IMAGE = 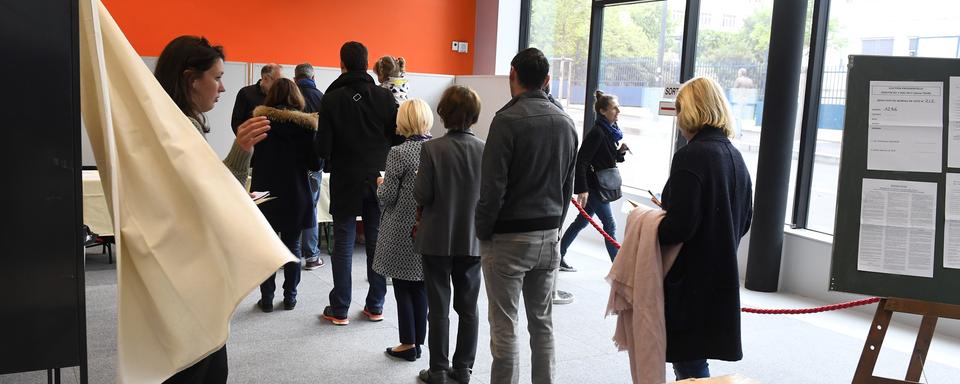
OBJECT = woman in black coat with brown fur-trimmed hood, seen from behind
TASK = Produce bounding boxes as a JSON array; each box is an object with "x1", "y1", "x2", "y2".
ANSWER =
[{"x1": 250, "y1": 79, "x2": 320, "y2": 312}]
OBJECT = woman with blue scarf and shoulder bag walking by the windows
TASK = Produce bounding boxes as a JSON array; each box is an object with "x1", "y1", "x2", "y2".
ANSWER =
[{"x1": 560, "y1": 91, "x2": 627, "y2": 272}]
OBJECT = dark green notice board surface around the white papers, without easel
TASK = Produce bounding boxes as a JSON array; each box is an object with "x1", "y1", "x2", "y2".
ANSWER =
[{"x1": 830, "y1": 56, "x2": 960, "y2": 304}]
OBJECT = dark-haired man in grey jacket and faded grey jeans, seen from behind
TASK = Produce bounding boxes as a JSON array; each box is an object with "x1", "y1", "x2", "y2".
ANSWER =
[{"x1": 476, "y1": 48, "x2": 577, "y2": 384}]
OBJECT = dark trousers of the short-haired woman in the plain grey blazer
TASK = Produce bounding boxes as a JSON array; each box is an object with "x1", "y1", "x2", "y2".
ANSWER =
[{"x1": 423, "y1": 255, "x2": 480, "y2": 371}]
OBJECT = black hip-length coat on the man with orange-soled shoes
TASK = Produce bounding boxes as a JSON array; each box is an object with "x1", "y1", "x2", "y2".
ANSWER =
[{"x1": 316, "y1": 71, "x2": 403, "y2": 216}]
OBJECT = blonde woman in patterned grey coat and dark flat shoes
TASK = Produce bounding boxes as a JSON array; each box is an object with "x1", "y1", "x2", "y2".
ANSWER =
[{"x1": 373, "y1": 99, "x2": 433, "y2": 361}]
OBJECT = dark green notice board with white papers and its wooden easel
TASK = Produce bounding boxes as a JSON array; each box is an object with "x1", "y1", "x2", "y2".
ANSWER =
[{"x1": 830, "y1": 56, "x2": 960, "y2": 383}]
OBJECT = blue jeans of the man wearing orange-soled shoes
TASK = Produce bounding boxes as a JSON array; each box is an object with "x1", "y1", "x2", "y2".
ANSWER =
[{"x1": 330, "y1": 186, "x2": 387, "y2": 316}]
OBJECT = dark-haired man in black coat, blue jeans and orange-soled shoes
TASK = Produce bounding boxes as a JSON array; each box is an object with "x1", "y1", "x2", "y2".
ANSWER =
[{"x1": 316, "y1": 41, "x2": 399, "y2": 325}]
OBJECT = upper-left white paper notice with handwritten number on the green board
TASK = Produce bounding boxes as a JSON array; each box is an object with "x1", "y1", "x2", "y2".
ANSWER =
[{"x1": 867, "y1": 81, "x2": 943, "y2": 172}]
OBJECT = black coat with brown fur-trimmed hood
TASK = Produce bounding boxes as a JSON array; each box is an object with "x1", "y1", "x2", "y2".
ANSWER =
[{"x1": 250, "y1": 106, "x2": 320, "y2": 232}]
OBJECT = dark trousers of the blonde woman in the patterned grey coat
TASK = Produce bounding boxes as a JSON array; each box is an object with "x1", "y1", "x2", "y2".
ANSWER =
[{"x1": 393, "y1": 278, "x2": 427, "y2": 345}]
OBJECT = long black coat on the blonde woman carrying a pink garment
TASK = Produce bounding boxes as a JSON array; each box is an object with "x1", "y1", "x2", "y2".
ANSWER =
[{"x1": 659, "y1": 126, "x2": 753, "y2": 362}]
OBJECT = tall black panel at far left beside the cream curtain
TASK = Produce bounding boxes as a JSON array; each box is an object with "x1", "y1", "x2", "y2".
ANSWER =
[{"x1": 0, "y1": 0, "x2": 89, "y2": 376}]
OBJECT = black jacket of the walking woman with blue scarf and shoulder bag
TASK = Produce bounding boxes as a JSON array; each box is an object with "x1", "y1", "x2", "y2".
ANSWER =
[{"x1": 573, "y1": 122, "x2": 623, "y2": 193}]
